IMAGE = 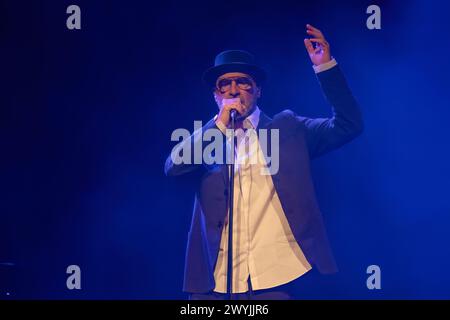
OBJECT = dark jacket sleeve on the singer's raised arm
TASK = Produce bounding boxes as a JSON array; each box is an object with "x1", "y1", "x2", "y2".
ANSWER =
[{"x1": 297, "y1": 65, "x2": 364, "y2": 158}]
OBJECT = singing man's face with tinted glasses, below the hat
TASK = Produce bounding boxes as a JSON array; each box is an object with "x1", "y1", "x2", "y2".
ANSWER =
[{"x1": 214, "y1": 72, "x2": 261, "y2": 118}]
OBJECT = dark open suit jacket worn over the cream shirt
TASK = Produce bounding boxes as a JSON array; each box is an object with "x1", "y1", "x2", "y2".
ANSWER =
[{"x1": 165, "y1": 66, "x2": 363, "y2": 293}]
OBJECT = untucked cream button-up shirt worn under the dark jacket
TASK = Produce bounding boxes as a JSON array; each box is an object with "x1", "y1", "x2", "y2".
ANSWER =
[{"x1": 214, "y1": 59, "x2": 337, "y2": 293}]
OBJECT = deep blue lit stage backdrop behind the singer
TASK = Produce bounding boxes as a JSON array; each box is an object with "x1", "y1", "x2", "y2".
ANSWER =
[{"x1": 0, "y1": 0, "x2": 450, "y2": 299}]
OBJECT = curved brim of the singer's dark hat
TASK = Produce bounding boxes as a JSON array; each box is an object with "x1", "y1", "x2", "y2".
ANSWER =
[{"x1": 202, "y1": 62, "x2": 266, "y2": 87}]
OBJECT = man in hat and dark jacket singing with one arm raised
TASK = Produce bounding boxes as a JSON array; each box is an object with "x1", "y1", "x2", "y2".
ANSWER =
[{"x1": 165, "y1": 25, "x2": 363, "y2": 299}]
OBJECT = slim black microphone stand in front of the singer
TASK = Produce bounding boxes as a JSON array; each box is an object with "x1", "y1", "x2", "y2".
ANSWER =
[{"x1": 227, "y1": 110, "x2": 236, "y2": 300}]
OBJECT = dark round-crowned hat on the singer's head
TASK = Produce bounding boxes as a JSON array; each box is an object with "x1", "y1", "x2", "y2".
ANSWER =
[{"x1": 203, "y1": 50, "x2": 266, "y2": 87}]
